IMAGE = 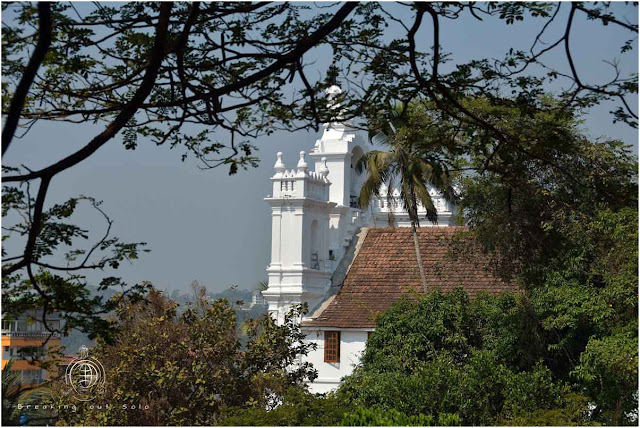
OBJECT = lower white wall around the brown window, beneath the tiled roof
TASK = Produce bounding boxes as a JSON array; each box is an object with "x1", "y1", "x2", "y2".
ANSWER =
[{"x1": 302, "y1": 327, "x2": 373, "y2": 393}]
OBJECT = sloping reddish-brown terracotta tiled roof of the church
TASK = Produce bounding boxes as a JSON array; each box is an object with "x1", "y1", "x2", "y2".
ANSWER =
[{"x1": 302, "y1": 227, "x2": 515, "y2": 328}]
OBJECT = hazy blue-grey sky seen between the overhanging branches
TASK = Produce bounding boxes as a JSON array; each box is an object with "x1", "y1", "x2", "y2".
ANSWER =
[{"x1": 3, "y1": 4, "x2": 638, "y2": 290}]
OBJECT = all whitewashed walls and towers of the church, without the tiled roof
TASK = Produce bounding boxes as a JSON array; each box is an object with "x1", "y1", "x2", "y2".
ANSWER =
[{"x1": 262, "y1": 86, "x2": 453, "y2": 393}]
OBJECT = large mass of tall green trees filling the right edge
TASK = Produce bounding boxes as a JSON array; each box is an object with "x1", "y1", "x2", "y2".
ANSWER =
[{"x1": 452, "y1": 111, "x2": 638, "y2": 425}]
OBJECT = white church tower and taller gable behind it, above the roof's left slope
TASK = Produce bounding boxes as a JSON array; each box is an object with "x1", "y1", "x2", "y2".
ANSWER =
[{"x1": 262, "y1": 86, "x2": 370, "y2": 322}]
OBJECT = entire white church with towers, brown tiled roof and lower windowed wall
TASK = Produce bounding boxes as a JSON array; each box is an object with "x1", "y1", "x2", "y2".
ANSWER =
[{"x1": 262, "y1": 87, "x2": 508, "y2": 393}]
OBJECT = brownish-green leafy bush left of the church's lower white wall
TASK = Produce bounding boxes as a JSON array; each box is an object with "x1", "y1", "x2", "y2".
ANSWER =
[{"x1": 50, "y1": 289, "x2": 316, "y2": 425}]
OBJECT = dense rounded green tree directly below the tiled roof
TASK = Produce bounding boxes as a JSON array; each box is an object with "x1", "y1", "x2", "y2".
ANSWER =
[{"x1": 339, "y1": 290, "x2": 567, "y2": 425}]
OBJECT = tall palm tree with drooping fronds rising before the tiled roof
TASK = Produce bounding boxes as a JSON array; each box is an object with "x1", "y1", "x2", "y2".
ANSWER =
[{"x1": 356, "y1": 104, "x2": 454, "y2": 292}]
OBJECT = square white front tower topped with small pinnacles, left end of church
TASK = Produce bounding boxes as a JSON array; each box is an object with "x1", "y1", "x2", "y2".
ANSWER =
[{"x1": 262, "y1": 152, "x2": 336, "y2": 323}]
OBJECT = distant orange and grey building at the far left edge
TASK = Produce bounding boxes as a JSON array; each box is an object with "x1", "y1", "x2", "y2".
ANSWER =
[{"x1": 2, "y1": 310, "x2": 61, "y2": 385}]
